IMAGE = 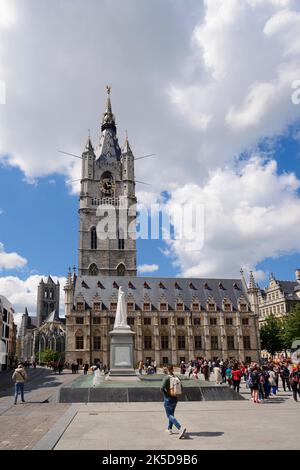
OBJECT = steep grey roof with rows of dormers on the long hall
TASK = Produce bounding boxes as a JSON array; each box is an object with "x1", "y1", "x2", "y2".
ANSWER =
[{"x1": 74, "y1": 276, "x2": 249, "y2": 309}]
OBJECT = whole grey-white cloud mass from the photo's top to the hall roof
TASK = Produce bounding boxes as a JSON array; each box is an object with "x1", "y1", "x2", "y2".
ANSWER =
[{"x1": 0, "y1": 0, "x2": 300, "y2": 275}]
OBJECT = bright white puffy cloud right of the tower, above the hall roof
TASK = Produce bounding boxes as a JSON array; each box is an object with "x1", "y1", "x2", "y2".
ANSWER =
[{"x1": 167, "y1": 157, "x2": 300, "y2": 278}]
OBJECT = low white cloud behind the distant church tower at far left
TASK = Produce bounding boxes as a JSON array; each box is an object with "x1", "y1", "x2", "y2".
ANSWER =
[{"x1": 0, "y1": 275, "x2": 66, "y2": 315}]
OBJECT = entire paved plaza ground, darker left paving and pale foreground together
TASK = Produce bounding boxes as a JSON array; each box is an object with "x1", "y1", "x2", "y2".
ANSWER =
[{"x1": 0, "y1": 369, "x2": 300, "y2": 450}]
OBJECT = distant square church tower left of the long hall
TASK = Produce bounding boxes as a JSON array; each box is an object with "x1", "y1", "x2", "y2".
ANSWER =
[{"x1": 36, "y1": 276, "x2": 60, "y2": 327}]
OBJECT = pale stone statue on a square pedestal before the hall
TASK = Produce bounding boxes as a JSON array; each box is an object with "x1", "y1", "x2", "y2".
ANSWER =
[{"x1": 107, "y1": 286, "x2": 138, "y2": 380}]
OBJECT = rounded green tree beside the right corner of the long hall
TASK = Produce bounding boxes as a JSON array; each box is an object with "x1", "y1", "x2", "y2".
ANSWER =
[{"x1": 260, "y1": 315, "x2": 285, "y2": 356}]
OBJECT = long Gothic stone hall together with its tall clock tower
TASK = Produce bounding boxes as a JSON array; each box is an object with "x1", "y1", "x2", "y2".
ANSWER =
[{"x1": 64, "y1": 87, "x2": 259, "y2": 365}]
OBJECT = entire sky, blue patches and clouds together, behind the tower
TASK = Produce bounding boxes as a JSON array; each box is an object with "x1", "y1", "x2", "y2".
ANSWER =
[{"x1": 0, "y1": 0, "x2": 300, "y2": 312}]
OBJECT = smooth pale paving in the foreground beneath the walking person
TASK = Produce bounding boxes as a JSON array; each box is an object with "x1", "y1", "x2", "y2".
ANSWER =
[{"x1": 55, "y1": 393, "x2": 300, "y2": 450}]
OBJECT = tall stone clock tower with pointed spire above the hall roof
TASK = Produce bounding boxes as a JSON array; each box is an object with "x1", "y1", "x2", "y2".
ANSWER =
[{"x1": 78, "y1": 87, "x2": 136, "y2": 276}]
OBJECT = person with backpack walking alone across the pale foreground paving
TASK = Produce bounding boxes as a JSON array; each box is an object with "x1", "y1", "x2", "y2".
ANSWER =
[{"x1": 161, "y1": 366, "x2": 186, "y2": 439}]
